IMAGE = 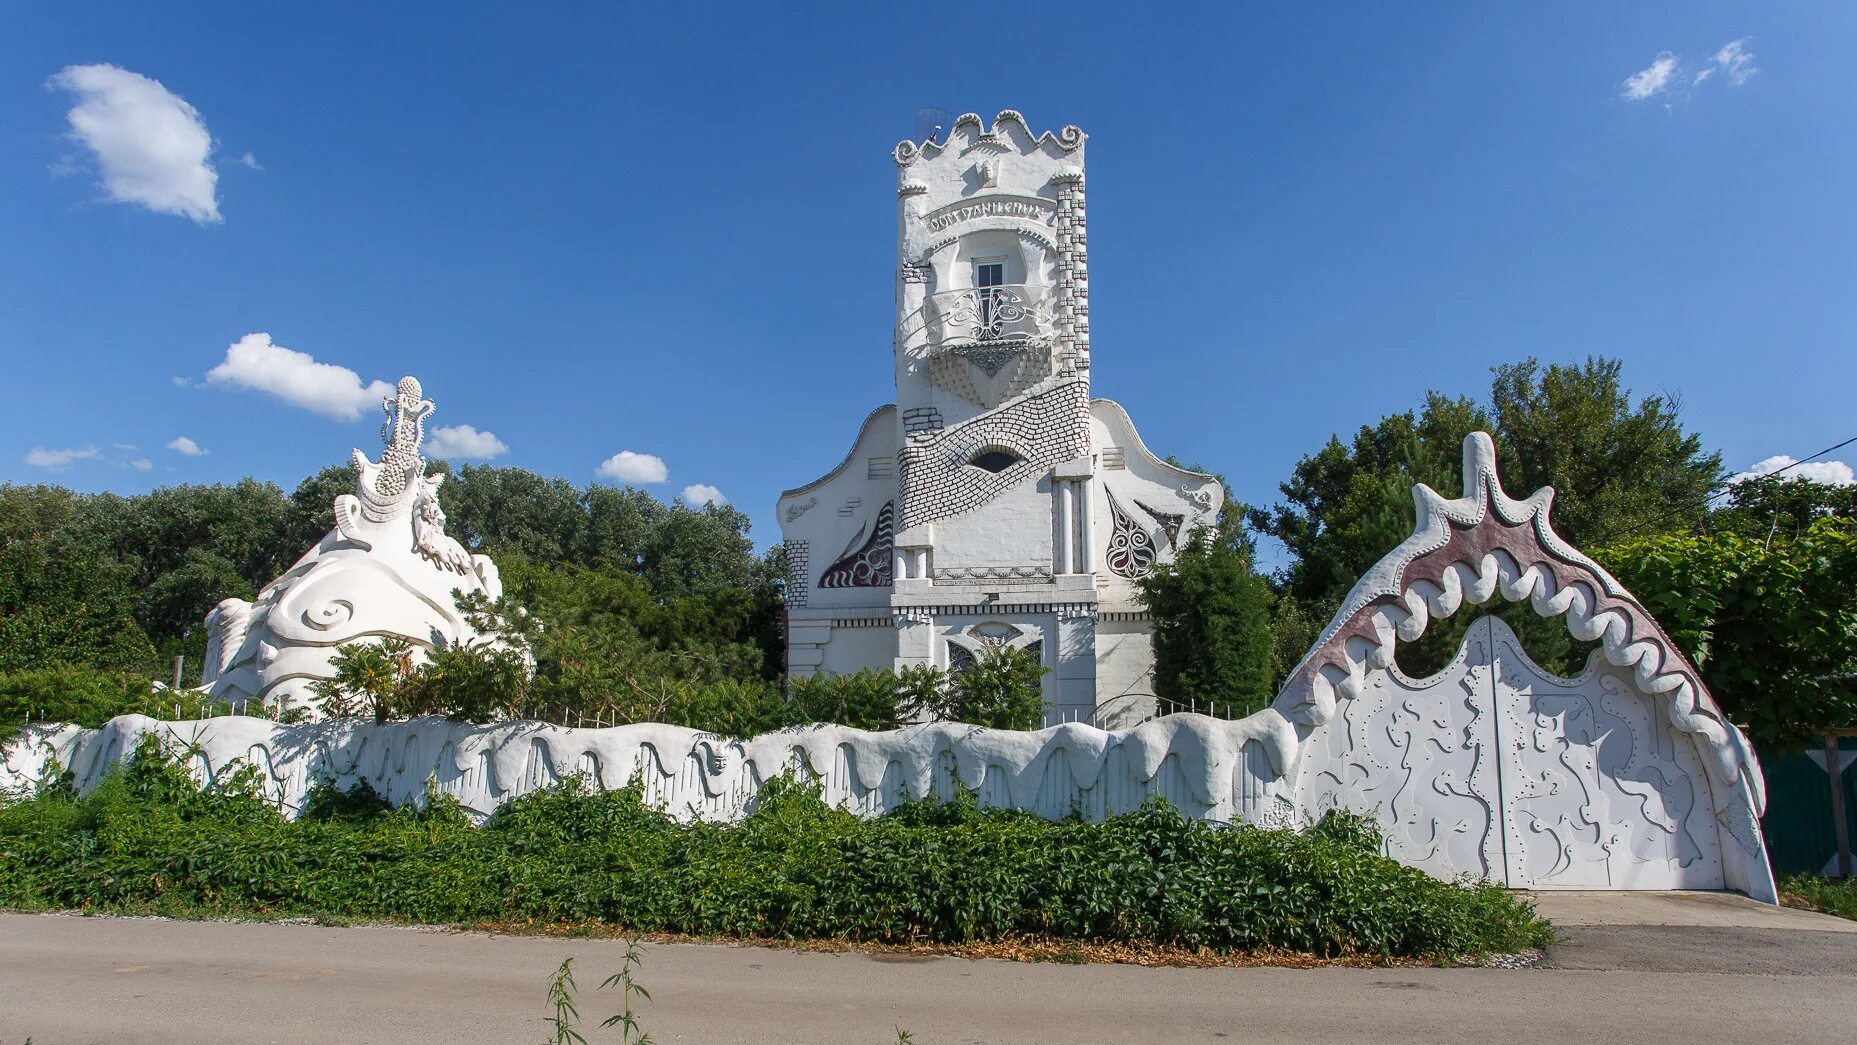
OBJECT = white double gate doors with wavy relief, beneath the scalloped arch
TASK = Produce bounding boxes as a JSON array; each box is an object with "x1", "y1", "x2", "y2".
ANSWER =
[{"x1": 1298, "y1": 616, "x2": 1723, "y2": 889}]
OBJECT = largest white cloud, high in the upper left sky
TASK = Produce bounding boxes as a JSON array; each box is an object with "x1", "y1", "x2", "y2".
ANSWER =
[{"x1": 45, "y1": 65, "x2": 219, "y2": 225}]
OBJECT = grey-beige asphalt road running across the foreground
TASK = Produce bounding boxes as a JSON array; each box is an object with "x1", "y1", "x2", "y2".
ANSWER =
[{"x1": 0, "y1": 900, "x2": 1857, "y2": 1045}]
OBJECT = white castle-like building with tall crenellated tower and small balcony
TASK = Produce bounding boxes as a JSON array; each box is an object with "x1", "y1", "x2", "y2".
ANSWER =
[{"x1": 778, "y1": 110, "x2": 1220, "y2": 728}]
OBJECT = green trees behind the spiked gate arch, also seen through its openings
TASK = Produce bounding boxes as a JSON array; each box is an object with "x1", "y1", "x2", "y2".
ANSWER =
[{"x1": 1250, "y1": 358, "x2": 1721, "y2": 676}]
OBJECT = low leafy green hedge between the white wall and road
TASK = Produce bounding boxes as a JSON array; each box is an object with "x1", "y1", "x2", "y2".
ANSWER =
[{"x1": 0, "y1": 746, "x2": 1549, "y2": 956}]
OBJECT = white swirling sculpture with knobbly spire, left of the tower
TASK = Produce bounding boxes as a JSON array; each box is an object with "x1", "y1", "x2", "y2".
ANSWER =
[{"x1": 202, "y1": 377, "x2": 503, "y2": 715}]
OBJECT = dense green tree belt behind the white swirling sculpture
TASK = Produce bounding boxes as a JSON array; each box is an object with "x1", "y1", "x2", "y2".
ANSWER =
[{"x1": 0, "y1": 462, "x2": 786, "y2": 703}]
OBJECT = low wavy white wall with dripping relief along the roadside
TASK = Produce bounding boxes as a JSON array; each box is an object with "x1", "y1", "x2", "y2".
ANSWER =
[{"x1": 0, "y1": 711, "x2": 1296, "y2": 822}]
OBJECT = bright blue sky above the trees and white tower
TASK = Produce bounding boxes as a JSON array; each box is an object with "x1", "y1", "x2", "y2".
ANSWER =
[{"x1": 0, "y1": 4, "x2": 1857, "y2": 567}]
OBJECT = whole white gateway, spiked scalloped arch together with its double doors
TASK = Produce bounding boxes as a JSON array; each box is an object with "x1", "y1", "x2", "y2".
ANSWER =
[{"x1": 1270, "y1": 432, "x2": 1777, "y2": 902}]
